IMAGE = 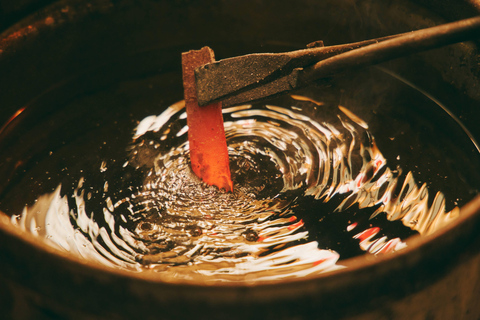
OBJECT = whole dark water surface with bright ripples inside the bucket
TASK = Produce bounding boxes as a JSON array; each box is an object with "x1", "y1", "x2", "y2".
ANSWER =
[{"x1": 0, "y1": 66, "x2": 479, "y2": 281}]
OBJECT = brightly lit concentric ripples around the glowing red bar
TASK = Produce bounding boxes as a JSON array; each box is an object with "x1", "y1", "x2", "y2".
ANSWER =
[{"x1": 12, "y1": 95, "x2": 459, "y2": 281}]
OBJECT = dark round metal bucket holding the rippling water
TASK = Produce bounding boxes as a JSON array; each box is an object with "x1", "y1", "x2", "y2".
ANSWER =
[{"x1": 0, "y1": 0, "x2": 480, "y2": 319}]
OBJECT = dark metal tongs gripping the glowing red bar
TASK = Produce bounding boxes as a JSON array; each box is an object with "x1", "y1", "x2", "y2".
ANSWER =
[{"x1": 195, "y1": 16, "x2": 480, "y2": 106}]
